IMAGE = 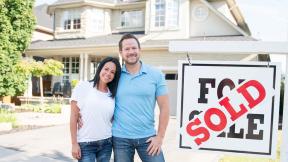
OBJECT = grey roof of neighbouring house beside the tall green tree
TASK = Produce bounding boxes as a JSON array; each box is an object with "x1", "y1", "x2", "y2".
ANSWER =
[{"x1": 33, "y1": 4, "x2": 53, "y2": 30}]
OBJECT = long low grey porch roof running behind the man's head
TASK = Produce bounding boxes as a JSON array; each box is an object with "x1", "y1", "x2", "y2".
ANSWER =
[{"x1": 28, "y1": 34, "x2": 256, "y2": 50}]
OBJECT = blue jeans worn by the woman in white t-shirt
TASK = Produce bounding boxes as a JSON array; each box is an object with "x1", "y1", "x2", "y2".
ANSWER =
[{"x1": 78, "y1": 137, "x2": 112, "y2": 162}]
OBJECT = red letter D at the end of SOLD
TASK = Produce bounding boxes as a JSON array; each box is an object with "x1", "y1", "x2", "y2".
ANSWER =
[{"x1": 237, "y1": 80, "x2": 266, "y2": 109}]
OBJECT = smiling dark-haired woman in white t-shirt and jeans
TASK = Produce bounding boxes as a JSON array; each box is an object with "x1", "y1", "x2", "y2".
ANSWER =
[{"x1": 70, "y1": 57, "x2": 121, "y2": 162}]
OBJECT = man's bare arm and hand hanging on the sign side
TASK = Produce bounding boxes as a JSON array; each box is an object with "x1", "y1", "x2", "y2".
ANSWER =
[{"x1": 147, "y1": 95, "x2": 170, "y2": 156}]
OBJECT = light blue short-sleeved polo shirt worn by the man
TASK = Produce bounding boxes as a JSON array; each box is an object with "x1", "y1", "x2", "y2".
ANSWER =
[{"x1": 112, "y1": 63, "x2": 167, "y2": 139}]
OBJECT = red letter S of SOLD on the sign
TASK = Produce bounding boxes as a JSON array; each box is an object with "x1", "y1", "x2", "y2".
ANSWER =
[{"x1": 186, "y1": 118, "x2": 210, "y2": 145}]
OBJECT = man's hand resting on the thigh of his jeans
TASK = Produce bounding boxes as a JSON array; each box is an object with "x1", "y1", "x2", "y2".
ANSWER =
[{"x1": 146, "y1": 136, "x2": 163, "y2": 156}]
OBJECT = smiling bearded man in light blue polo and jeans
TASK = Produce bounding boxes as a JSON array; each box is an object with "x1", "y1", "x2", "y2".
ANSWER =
[{"x1": 112, "y1": 34, "x2": 169, "y2": 162}]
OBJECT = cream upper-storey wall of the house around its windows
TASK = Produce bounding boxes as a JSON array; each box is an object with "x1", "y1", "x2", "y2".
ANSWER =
[{"x1": 50, "y1": 0, "x2": 241, "y2": 40}]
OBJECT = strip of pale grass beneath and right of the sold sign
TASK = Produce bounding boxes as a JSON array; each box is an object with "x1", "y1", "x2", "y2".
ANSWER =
[{"x1": 219, "y1": 131, "x2": 282, "y2": 162}]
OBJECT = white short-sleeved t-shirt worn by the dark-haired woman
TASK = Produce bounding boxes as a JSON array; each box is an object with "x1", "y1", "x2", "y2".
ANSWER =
[{"x1": 71, "y1": 81, "x2": 115, "y2": 142}]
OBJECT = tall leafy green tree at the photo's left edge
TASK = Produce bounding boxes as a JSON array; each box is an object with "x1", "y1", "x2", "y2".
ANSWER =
[{"x1": 0, "y1": 0, "x2": 35, "y2": 96}]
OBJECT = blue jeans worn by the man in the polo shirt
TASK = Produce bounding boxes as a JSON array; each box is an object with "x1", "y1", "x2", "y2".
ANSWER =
[{"x1": 113, "y1": 137, "x2": 165, "y2": 162}]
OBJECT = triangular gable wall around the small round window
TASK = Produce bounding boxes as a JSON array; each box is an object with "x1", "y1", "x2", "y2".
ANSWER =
[{"x1": 190, "y1": 0, "x2": 242, "y2": 37}]
